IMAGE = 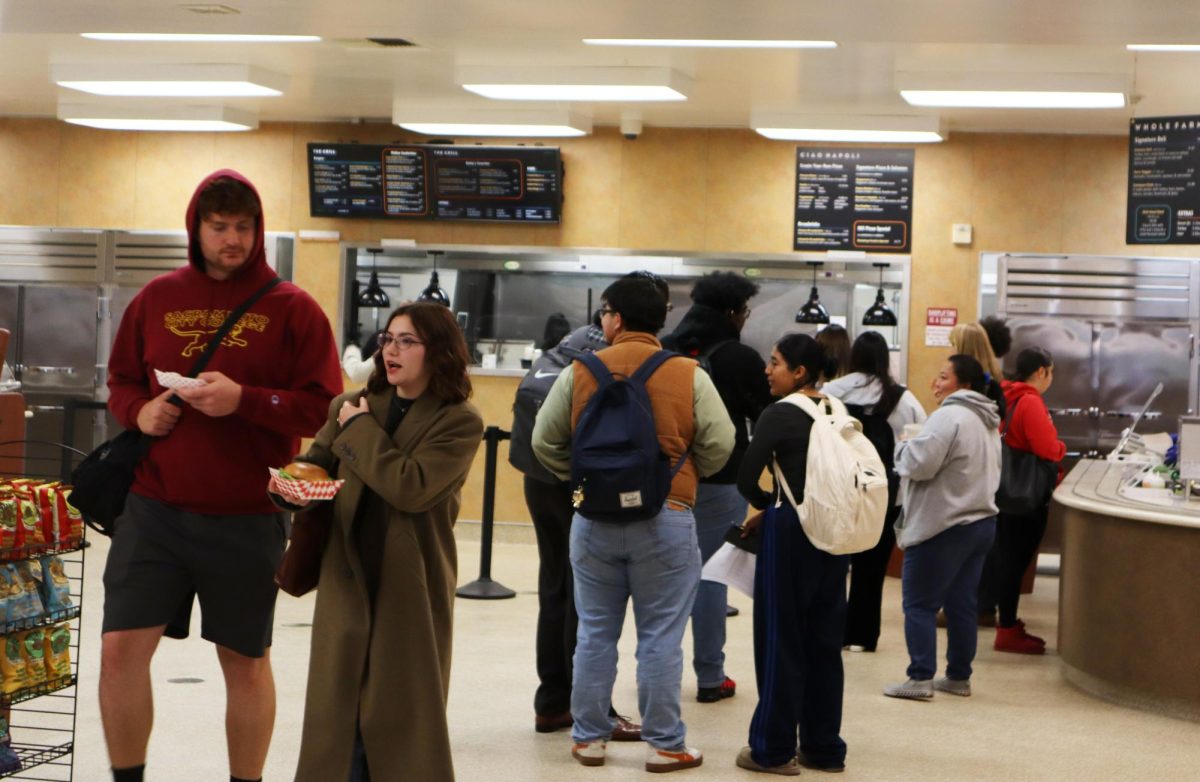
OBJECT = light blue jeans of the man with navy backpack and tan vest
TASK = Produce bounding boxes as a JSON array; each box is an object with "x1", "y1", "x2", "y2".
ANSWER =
[{"x1": 571, "y1": 509, "x2": 700, "y2": 750}]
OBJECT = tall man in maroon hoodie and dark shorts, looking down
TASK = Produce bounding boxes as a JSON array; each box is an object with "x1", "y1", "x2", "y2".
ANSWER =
[{"x1": 100, "y1": 170, "x2": 342, "y2": 782}]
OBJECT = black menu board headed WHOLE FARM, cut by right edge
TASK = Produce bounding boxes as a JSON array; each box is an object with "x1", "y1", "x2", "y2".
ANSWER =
[{"x1": 1126, "y1": 116, "x2": 1200, "y2": 245}]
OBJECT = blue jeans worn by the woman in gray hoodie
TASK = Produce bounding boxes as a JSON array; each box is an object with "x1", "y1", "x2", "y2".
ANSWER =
[{"x1": 901, "y1": 516, "x2": 996, "y2": 680}]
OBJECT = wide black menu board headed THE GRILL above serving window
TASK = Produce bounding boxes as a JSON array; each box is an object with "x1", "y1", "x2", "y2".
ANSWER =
[{"x1": 308, "y1": 143, "x2": 563, "y2": 223}]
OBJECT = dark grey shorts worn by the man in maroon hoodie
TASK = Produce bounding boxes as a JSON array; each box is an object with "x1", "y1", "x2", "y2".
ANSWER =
[{"x1": 103, "y1": 494, "x2": 287, "y2": 657}]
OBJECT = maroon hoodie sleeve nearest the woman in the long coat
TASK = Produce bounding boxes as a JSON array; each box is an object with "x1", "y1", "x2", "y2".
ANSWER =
[{"x1": 238, "y1": 294, "x2": 342, "y2": 437}]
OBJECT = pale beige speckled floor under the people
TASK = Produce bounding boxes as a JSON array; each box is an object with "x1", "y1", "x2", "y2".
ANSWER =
[{"x1": 76, "y1": 525, "x2": 1200, "y2": 782}]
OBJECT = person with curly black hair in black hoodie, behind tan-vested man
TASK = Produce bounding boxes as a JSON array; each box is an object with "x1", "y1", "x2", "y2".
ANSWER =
[{"x1": 662, "y1": 271, "x2": 772, "y2": 703}]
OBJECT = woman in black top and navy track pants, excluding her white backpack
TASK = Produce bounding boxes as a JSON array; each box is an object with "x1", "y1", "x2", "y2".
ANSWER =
[{"x1": 737, "y1": 333, "x2": 850, "y2": 776}]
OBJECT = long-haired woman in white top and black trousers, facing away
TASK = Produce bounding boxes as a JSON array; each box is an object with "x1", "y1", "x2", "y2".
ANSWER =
[{"x1": 821, "y1": 331, "x2": 926, "y2": 651}]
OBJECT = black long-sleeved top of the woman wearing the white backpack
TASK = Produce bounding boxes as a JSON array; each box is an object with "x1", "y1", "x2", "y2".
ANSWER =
[{"x1": 738, "y1": 402, "x2": 812, "y2": 510}]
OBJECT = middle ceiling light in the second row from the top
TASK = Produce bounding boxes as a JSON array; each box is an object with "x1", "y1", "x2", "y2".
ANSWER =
[{"x1": 458, "y1": 67, "x2": 690, "y2": 102}]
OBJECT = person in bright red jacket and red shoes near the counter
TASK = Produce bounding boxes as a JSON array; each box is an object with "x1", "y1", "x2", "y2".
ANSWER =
[{"x1": 995, "y1": 348, "x2": 1067, "y2": 655}]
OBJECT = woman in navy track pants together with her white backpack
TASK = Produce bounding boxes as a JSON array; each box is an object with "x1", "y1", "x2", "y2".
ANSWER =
[{"x1": 737, "y1": 333, "x2": 888, "y2": 776}]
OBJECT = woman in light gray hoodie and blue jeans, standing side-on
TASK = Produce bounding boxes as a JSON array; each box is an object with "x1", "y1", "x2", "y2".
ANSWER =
[{"x1": 883, "y1": 354, "x2": 1001, "y2": 699}]
